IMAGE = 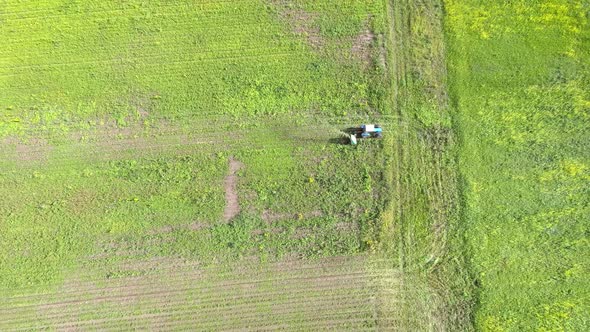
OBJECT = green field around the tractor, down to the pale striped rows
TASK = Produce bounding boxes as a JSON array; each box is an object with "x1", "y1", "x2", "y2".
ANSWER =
[{"x1": 0, "y1": 1, "x2": 384, "y2": 287}]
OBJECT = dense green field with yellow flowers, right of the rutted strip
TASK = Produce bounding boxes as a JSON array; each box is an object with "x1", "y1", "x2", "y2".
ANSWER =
[{"x1": 445, "y1": 0, "x2": 590, "y2": 331}]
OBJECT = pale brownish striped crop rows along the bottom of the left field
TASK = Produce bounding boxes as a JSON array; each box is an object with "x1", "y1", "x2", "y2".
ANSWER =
[{"x1": 0, "y1": 257, "x2": 398, "y2": 330}]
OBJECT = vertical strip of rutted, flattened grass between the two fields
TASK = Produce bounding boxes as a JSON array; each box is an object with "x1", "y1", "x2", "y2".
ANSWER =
[{"x1": 382, "y1": 0, "x2": 473, "y2": 331}]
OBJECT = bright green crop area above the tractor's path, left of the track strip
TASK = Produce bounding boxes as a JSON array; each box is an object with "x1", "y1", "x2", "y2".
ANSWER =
[{"x1": 0, "y1": 0, "x2": 384, "y2": 136}]
